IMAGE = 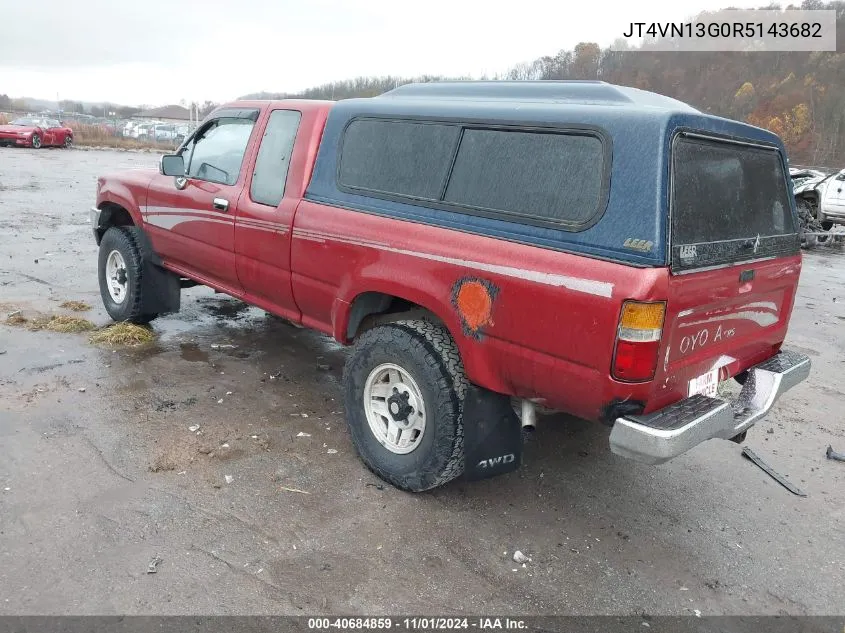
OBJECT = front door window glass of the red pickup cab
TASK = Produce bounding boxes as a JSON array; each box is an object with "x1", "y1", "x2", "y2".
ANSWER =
[{"x1": 183, "y1": 118, "x2": 255, "y2": 185}]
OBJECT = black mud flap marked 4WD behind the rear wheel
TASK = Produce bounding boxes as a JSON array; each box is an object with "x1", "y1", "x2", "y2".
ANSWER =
[{"x1": 463, "y1": 385, "x2": 522, "y2": 481}]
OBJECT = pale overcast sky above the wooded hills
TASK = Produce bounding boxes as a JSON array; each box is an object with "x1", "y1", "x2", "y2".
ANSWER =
[{"x1": 0, "y1": 0, "x2": 765, "y2": 105}]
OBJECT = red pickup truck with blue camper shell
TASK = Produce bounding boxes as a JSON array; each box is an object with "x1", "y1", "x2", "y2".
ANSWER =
[{"x1": 91, "y1": 82, "x2": 810, "y2": 491}]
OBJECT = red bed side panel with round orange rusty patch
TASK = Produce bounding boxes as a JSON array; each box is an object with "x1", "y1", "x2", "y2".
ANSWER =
[{"x1": 292, "y1": 200, "x2": 667, "y2": 419}]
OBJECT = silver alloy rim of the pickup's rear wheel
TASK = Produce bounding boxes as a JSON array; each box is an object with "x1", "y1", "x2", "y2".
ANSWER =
[{"x1": 364, "y1": 363, "x2": 425, "y2": 455}]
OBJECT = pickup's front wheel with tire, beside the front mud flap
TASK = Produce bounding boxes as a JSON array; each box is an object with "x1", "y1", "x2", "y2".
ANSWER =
[{"x1": 98, "y1": 226, "x2": 158, "y2": 324}]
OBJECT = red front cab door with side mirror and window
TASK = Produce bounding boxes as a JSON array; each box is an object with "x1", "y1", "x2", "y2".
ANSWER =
[{"x1": 143, "y1": 109, "x2": 259, "y2": 295}]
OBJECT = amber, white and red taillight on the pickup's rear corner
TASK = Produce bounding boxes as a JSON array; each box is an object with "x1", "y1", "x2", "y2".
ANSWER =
[{"x1": 613, "y1": 301, "x2": 666, "y2": 382}]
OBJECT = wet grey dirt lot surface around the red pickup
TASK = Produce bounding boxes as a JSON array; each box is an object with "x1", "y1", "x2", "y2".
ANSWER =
[{"x1": 0, "y1": 149, "x2": 845, "y2": 615}]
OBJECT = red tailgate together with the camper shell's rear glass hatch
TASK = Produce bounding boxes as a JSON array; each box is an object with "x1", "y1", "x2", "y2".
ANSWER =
[{"x1": 648, "y1": 133, "x2": 801, "y2": 410}]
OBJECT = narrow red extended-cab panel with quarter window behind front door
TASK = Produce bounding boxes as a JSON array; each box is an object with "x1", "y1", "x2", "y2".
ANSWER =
[{"x1": 235, "y1": 109, "x2": 302, "y2": 321}]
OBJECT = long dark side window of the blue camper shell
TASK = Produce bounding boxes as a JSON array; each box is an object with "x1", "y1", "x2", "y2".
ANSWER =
[{"x1": 337, "y1": 117, "x2": 611, "y2": 231}]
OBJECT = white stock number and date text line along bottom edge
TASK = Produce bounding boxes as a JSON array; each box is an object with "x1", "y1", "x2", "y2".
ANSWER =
[{"x1": 308, "y1": 617, "x2": 528, "y2": 631}]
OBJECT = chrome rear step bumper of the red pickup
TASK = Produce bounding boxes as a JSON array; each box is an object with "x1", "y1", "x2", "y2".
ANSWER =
[{"x1": 610, "y1": 350, "x2": 810, "y2": 464}]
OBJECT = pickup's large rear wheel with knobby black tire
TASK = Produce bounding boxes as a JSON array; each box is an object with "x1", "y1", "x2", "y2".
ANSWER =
[{"x1": 343, "y1": 320, "x2": 467, "y2": 492}]
